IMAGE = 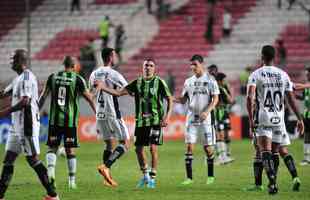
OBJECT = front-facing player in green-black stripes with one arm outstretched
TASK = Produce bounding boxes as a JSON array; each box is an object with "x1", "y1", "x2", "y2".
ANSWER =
[{"x1": 98, "y1": 58, "x2": 173, "y2": 188}]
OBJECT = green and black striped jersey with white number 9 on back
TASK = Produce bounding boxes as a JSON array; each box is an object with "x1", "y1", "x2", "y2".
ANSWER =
[{"x1": 46, "y1": 71, "x2": 88, "y2": 127}]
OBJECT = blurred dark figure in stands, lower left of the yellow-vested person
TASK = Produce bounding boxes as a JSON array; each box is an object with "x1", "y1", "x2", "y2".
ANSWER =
[{"x1": 80, "y1": 38, "x2": 96, "y2": 79}]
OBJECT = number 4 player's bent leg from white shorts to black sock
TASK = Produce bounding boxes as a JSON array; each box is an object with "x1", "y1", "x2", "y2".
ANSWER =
[{"x1": 104, "y1": 119, "x2": 129, "y2": 168}]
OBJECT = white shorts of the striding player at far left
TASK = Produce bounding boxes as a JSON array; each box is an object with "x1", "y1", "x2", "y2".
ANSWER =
[{"x1": 5, "y1": 134, "x2": 40, "y2": 156}]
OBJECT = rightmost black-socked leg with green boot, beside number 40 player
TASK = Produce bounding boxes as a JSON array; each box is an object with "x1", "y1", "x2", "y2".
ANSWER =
[{"x1": 279, "y1": 146, "x2": 301, "y2": 191}]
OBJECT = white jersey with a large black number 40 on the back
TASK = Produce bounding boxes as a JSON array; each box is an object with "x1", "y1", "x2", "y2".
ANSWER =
[{"x1": 248, "y1": 66, "x2": 293, "y2": 126}]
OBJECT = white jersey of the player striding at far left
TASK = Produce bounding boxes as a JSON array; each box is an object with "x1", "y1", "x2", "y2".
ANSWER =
[{"x1": 5, "y1": 69, "x2": 40, "y2": 136}]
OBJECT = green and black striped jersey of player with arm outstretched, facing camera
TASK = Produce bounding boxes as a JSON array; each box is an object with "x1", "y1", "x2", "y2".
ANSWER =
[{"x1": 126, "y1": 76, "x2": 171, "y2": 127}]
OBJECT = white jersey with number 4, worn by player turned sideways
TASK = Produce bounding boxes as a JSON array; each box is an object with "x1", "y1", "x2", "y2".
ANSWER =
[{"x1": 89, "y1": 66, "x2": 127, "y2": 120}]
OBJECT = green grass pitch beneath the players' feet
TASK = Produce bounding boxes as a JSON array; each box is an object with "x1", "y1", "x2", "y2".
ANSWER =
[{"x1": 0, "y1": 140, "x2": 310, "y2": 200}]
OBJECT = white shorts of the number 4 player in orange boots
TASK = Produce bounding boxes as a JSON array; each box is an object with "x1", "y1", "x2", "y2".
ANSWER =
[{"x1": 96, "y1": 119, "x2": 129, "y2": 141}]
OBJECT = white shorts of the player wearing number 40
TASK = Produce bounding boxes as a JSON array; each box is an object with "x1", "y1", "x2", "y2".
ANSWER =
[{"x1": 255, "y1": 125, "x2": 290, "y2": 145}]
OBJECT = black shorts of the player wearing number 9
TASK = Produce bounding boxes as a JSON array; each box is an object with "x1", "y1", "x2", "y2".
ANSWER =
[{"x1": 46, "y1": 126, "x2": 79, "y2": 148}]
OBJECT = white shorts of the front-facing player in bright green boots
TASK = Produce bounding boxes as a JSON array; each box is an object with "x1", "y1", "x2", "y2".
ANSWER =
[{"x1": 185, "y1": 124, "x2": 216, "y2": 146}]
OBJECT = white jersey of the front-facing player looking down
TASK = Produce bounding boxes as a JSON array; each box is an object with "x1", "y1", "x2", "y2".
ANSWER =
[{"x1": 182, "y1": 73, "x2": 220, "y2": 125}]
